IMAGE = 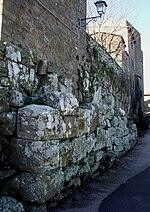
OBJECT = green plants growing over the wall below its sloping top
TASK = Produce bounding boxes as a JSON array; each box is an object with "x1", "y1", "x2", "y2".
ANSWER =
[{"x1": 77, "y1": 42, "x2": 128, "y2": 103}]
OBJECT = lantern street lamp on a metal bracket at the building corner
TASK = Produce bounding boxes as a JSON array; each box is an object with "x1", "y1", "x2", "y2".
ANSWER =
[{"x1": 77, "y1": 0, "x2": 107, "y2": 29}]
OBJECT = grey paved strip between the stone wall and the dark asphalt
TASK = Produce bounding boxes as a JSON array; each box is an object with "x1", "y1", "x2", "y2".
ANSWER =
[{"x1": 48, "y1": 130, "x2": 150, "y2": 212}]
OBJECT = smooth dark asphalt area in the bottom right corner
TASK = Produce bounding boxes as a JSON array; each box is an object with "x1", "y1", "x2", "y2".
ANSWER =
[{"x1": 98, "y1": 168, "x2": 150, "y2": 212}]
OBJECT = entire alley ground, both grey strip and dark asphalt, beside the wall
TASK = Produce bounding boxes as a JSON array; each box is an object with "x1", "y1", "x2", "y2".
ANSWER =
[{"x1": 49, "y1": 130, "x2": 150, "y2": 212}]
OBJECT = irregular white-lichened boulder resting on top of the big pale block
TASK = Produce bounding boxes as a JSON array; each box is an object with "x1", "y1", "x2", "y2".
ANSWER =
[{"x1": 43, "y1": 91, "x2": 79, "y2": 115}]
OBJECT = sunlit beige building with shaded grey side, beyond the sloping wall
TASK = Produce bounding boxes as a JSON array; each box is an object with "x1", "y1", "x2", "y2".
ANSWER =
[{"x1": 87, "y1": 20, "x2": 144, "y2": 113}]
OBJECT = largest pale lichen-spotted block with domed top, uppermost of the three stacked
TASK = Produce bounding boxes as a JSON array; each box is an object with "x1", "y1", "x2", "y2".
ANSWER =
[{"x1": 17, "y1": 104, "x2": 77, "y2": 141}]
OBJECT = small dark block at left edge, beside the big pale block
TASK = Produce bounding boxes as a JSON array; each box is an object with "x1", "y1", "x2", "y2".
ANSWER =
[{"x1": 0, "y1": 112, "x2": 16, "y2": 135}]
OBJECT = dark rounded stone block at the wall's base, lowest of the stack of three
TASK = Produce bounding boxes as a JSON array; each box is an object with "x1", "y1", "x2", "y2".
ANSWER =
[{"x1": 5, "y1": 170, "x2": 64, "y2": 204}]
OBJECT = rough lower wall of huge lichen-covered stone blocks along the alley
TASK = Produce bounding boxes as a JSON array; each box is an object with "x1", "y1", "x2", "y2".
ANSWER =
[{"x1": 0, "y1": 35, "x2": 137, "y2": 207}]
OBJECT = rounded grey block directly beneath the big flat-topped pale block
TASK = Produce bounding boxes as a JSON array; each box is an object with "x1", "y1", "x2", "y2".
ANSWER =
[{"x1": 11, "y1": 139, "x2": 59, "y2": 173}]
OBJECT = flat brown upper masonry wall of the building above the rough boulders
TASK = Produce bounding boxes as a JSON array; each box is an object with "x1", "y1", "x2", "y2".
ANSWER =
[{"x1": 1, "y1": 0, "x2": 86, "y2": 94}]
